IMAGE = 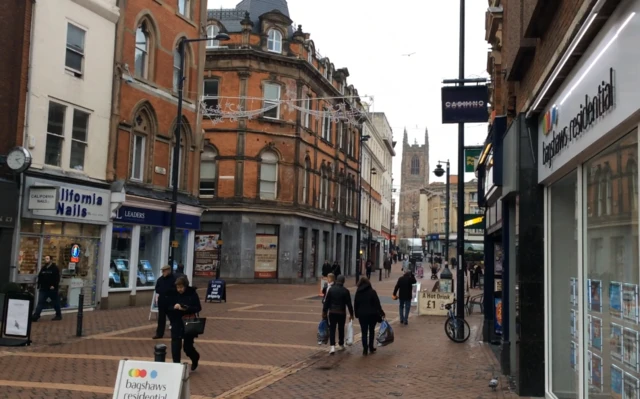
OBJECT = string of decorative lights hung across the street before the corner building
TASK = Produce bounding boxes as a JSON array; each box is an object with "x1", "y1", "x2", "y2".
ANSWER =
[{"x1": 200, "y1": 90, "x2": 373, "y2": 126}]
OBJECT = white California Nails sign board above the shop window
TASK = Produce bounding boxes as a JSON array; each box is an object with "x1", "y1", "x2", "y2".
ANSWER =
[{"x1": 23, "y1": 177, "x2": 111, "y2": 224}]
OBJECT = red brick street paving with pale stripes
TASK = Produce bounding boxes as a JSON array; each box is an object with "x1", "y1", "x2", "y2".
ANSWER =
[{"x1": 0, "y1": 264, "x2": 524, "y2": 399}]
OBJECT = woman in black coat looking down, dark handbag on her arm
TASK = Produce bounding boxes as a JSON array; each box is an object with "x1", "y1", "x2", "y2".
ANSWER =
[{"x1": 167, "y1": 276, "x2": 202, "y2": 371}]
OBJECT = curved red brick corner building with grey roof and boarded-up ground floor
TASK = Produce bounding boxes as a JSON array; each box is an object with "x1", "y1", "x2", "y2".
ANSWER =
[{"x1": 199, "y1": 0, "x2": 361, "y2": 281}]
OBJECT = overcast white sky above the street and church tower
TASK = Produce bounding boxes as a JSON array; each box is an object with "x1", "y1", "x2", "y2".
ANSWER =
[{"x1": 208, "y1": 0, "x2": 489, "y2": 202}]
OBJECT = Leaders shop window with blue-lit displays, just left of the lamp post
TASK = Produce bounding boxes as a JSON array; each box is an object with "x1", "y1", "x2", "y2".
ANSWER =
[{"x1": 136, "y1": 226, "x2": 163, "y2": 287}]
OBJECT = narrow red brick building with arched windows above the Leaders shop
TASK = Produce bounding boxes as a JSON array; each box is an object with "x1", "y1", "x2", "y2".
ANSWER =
[{"x1": 102, "y1": 0, "x2": 207, "y2": 307}]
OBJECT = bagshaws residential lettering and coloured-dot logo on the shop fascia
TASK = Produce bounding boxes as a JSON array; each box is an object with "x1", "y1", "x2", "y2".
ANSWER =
[{"x1": 541, "y1": 68, "x2": 615, "y2": 168}]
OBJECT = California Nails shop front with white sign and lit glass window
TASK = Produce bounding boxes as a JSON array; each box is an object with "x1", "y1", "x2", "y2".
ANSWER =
[{"x1": 13, "y1": 176, "x2": 111, "y2": 310}]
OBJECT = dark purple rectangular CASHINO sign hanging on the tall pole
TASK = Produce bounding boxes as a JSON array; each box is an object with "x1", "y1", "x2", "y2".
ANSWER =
[{"x1": 442, "y1": 85, "x2": 489, "y2": 123}]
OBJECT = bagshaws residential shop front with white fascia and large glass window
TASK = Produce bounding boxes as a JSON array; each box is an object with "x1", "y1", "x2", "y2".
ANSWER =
[{"x1": 544, "y1": 0, "x2": 640, "y2": 398}]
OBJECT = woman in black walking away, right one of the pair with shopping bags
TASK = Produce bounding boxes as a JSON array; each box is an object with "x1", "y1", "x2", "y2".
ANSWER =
[{"x1": 354, "y1": 277, "x2": 385, "y2": 356}]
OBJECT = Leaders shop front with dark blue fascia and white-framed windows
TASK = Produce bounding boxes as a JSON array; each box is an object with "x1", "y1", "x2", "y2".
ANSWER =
[{"x1": 101, "y1": 197, "x2": 202, "y2": 309}]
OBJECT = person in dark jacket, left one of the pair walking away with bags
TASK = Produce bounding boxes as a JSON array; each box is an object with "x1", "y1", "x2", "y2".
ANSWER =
[{"x1": 322, "y1": 276, "x2": 353, "y2": 355}]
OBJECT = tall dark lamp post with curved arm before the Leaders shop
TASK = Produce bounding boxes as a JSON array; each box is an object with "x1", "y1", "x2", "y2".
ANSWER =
[{"x1": 169, "y1": 33, "x2": 229, "y2": 268}]
